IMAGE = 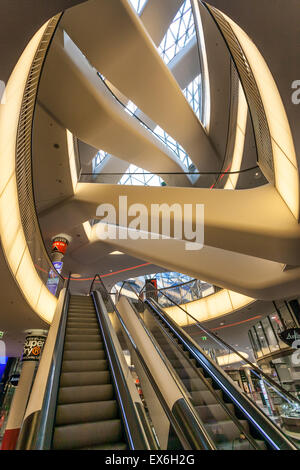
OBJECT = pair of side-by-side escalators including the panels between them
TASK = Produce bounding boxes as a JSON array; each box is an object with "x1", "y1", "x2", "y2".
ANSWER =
[{"x1": 17, "y1": 279, "x2": 297, "y2": 451}]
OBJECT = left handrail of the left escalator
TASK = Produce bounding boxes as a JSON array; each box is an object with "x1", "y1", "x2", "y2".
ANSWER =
[{"x1": 33, "y1": 273, "x2": 71, "y2": 450}]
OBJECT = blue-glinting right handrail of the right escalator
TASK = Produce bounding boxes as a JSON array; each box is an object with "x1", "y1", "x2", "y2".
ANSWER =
[{"x1": 145, "y1": 299, "x2": 298, "y2": 450}]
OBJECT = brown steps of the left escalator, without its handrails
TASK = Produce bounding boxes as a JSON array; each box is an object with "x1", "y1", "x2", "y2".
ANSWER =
[{"x1": 53, "y1": 296, "x2": 128, "y2": 450}]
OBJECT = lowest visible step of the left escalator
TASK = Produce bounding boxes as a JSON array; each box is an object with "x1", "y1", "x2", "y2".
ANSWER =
[{"x1": 53, "y1": 419, "x2": 123, "y2": 450}]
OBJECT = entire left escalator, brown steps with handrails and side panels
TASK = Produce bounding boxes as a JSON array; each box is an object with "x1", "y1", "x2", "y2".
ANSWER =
[{"x1": 16, "y1": 281, "x2": 157, "y2": 451}]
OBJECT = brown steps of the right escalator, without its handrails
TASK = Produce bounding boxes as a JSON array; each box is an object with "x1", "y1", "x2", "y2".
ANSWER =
[{"x1": 118, "y1": 282, "x2": 265, "y2": 450}]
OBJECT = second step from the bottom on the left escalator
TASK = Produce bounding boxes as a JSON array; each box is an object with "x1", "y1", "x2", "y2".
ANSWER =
[{"x1": 55, "y1": 400, "x2": 118, "y2": 426}]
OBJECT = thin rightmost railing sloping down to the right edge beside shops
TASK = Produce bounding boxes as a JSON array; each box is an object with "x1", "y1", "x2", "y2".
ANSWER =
[{"x1": 161, "y1": 292, "x2": 300, "y2": 405}]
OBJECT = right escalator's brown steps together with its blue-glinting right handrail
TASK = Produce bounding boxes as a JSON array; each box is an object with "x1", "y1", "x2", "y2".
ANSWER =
[{"x1": 144, "y1": 299, "x2": 297, "y2": 450}]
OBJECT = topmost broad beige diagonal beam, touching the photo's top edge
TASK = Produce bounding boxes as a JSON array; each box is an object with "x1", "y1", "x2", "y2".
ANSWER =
[{"x1": 61, "y1": 0, "x2": 219, "y2": 171}]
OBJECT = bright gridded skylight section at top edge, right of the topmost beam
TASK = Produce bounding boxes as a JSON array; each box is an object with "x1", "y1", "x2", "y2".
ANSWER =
[{"x1": 158, "y1": 0, "x2": 195, "y2": 64}]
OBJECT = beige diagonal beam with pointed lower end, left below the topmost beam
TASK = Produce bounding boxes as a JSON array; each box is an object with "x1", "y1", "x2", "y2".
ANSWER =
[{"x1": 39, "y1": 28, "x2": 189, "y2": 185}]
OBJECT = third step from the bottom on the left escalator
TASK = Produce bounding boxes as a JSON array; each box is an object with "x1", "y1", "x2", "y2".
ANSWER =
[{"x1": 58, "y1": 384, "x2": 114, "y2": 405}]
